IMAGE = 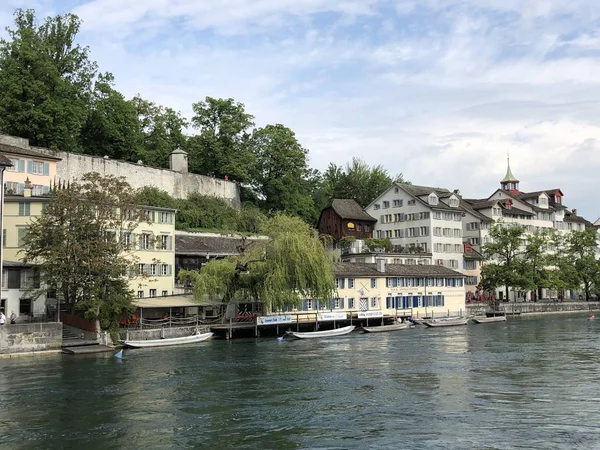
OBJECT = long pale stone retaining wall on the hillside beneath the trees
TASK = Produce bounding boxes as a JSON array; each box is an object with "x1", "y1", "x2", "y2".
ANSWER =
[{"x1": 49, "y1": 148, "x2": 241, "y2": 208}]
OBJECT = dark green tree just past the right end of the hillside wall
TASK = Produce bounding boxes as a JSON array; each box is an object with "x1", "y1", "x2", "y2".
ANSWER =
[{"x1": 252, "y1": 124, "x2": 316, "y2": 222}]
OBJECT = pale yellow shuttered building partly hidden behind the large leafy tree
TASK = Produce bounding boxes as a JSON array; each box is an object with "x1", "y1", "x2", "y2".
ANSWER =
[{"x1": 2, "y1": 188, "x2": 176, "y2": 320}]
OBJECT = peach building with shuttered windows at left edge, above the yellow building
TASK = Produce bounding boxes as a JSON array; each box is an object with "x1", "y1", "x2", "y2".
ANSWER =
[{"x1": 0, "y1": 138, "x2": 60, "y2": 196}]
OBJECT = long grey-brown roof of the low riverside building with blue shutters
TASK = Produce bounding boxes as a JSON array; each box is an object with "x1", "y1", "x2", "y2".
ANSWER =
[{"x1": 334, "y1": 263, "x2": 464, "y2": 278}]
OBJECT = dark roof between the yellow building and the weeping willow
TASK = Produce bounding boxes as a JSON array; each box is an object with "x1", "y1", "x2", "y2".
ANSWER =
[{"x1": 175, "y1": 231, "x2": 267, "y2": 256}]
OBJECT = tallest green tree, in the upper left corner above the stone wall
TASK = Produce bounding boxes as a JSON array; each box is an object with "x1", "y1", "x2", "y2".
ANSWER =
[{"x1": 0, "y1": 9, "x2": 97, "y2": 151}]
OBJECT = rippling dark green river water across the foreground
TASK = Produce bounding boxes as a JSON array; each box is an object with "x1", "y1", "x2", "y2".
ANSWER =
[{"x1": 0, "y1": 314, "x2": 600, "y2": 450}]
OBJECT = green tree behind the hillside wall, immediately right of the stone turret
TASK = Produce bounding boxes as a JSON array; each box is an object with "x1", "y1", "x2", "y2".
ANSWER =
[{"x1": 188, "y1": 97, "x2": 256, "y2": 183}]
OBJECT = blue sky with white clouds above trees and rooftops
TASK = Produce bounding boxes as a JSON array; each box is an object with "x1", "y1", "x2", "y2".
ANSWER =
[{"x1": 0, "y1": 0, "x2": 600, "y2": 221}]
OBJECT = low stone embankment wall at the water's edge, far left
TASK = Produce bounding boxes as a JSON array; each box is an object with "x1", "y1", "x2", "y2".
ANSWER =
[{"x1": 0, "y1": 322, "x2": 62, "y2": 354}]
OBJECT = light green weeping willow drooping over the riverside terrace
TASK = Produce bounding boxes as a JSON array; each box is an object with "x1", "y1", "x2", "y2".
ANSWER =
[{"x1": 179, "y1": 214, "x2": 335, "y2": 311}]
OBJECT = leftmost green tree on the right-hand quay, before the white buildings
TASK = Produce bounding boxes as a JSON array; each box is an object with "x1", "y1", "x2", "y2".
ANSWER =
[{"x1": 481, "y1": 222, "x2": 527, "y2": 300}]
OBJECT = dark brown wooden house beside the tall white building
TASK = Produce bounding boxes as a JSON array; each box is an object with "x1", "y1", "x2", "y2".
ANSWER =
[{"x1": 317, "y1": 198, "x2": 377, "y2": 241}]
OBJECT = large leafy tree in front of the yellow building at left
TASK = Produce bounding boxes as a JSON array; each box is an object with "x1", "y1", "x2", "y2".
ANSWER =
[{"x1": 23, "y1": 173, "x2": 147, "y2": 329}]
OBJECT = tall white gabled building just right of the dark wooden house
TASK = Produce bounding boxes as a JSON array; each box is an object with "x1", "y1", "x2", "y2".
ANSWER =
[{"x1": 365, "y1": 183, "x2": 466, "y2": 270}]
